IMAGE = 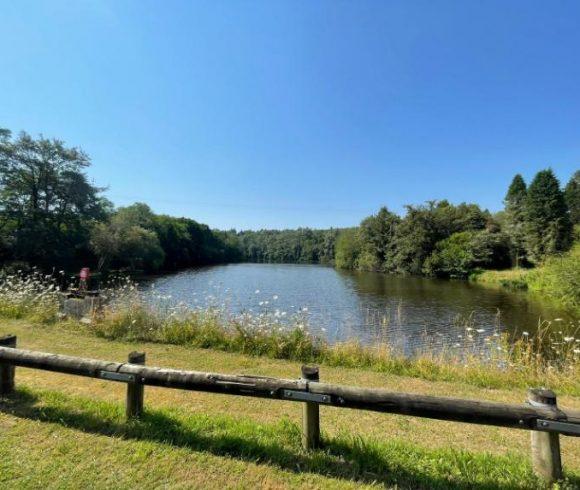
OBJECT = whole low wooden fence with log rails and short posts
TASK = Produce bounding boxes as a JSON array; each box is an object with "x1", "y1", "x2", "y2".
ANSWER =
[{"x1": 0, "y1": 335, "x2": 580, "y2": 482}]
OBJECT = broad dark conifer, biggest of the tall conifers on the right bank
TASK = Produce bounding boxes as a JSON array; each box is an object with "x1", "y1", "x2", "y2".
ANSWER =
[{"x1": 526, "y1": 169, "x2": 572, "y2": 263}]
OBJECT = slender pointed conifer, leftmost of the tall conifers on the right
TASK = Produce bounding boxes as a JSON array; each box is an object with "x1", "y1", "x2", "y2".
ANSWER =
[{"x1": 503, "y1": 174, "x2": 528, "y2": 267}]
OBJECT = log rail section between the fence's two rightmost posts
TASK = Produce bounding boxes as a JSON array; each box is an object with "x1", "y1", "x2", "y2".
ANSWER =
[{"x1": 308, "y1": 383, "x2": 566, "y2": 429}]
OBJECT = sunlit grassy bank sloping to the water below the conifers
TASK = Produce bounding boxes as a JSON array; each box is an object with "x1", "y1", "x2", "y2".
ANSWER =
[{"x1": 472, "y1": 242, "x2": 580, "y2": 314}]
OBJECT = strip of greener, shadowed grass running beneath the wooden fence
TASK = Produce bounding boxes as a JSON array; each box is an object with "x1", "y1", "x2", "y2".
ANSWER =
[{"x1": 0, "y1": 389, "x2": 580, "y2": 490}]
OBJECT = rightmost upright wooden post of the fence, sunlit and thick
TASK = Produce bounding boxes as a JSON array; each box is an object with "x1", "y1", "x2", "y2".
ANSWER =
[{"x1": 528, "y1": 389, "x2": 562, "y2": 483}]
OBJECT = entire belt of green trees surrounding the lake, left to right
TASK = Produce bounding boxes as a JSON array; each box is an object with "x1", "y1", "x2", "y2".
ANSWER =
[{"x1": 0, "y1": 129, "x2": 580, "y2": 277}]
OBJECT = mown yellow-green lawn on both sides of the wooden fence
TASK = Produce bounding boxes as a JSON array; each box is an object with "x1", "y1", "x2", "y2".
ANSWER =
[{"x1": 0, "y1": 320, "x2": 580, "y2": 489}]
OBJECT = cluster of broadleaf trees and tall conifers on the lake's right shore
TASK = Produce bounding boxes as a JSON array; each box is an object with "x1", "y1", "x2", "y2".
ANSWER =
[{"x1": 335, "y1": 169, "x2": 580, "y2": 277}]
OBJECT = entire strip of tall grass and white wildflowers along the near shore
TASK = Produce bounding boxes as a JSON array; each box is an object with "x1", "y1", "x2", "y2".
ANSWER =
[{"x1": 0, "y1": 278, "x2": 580, "y2": 395}]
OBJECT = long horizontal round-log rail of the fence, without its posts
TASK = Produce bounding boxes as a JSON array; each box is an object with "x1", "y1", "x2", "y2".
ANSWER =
[{"x1": 0, "y1": 347, "x2": 567, "y2": 430}]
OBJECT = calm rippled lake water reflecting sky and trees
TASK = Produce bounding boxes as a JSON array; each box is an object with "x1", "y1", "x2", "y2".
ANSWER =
[{"x1": 143, "y1": 264, "x2": 577, "y2": 353}]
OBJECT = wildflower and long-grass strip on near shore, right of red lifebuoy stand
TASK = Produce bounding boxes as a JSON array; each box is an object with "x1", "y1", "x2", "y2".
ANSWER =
[{"x1": 86, "y1": 304, "x2": 580, "y2": 395}]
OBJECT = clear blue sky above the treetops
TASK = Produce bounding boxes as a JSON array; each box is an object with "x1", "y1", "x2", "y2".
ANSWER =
[{"x1": 0, "y1": 0, "x2": 580, "y2": 229}]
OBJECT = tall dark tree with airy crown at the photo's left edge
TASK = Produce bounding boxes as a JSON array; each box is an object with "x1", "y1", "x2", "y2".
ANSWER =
[{"x1": 0, "y1": 130, "x2": 110, "y2": 267}]
